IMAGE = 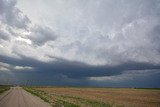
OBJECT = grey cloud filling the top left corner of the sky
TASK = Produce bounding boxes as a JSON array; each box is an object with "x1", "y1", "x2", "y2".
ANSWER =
[{"x1": 0, "y1": 0, "x2": 30, "y2": 28}]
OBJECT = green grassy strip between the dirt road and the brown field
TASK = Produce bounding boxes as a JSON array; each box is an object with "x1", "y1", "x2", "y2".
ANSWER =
[{"x1": 24, "y1": 87, "x2": 111, "y2": 107}]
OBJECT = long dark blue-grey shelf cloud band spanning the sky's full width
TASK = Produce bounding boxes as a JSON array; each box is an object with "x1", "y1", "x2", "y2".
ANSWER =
[{"x1": 0, "y1": 56, "x2": 160, "y2": 78}]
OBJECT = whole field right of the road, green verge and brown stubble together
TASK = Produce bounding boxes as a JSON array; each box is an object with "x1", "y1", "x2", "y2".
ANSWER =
[{"x1": 25, "y1": 87, "x2": 160, "y2": 107}]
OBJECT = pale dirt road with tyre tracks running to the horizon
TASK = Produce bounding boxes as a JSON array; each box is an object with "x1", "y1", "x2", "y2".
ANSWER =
[{"x1": 0, "y1": 87, "x2": 51, "y2": 107}]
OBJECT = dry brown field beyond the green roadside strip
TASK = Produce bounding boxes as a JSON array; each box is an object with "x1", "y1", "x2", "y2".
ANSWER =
[{"x1": 34, "y1": 87, "x2": 160, "y2": 107}]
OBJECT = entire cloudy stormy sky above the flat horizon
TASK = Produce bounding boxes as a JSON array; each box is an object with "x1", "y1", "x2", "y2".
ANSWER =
[{"x1": 0, "y1": 0, "x2": 160, "y2": 87}]
